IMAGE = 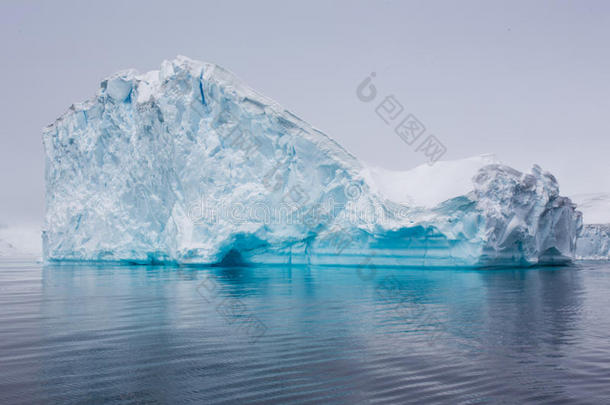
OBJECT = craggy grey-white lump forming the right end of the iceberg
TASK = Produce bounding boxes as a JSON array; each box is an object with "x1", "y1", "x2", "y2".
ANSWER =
[{"x1": 474, "y1": 165, "x2": 582, "y2": 263}]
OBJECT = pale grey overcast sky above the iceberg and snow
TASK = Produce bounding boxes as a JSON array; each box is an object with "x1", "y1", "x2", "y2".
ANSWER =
[{"x1": 0, "y1": 0, "x2": 610, "y2": 222}]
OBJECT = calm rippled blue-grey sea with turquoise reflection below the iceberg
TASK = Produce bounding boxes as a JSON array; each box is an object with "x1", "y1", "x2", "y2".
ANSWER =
[{"x1": 0, "y1": 260, "x2": 610, "y2": 404}]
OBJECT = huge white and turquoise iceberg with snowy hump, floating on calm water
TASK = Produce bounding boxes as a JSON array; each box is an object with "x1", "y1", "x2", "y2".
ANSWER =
[{"x1": 43, "y1": 57, "x2": 581, "y2": 266}]
